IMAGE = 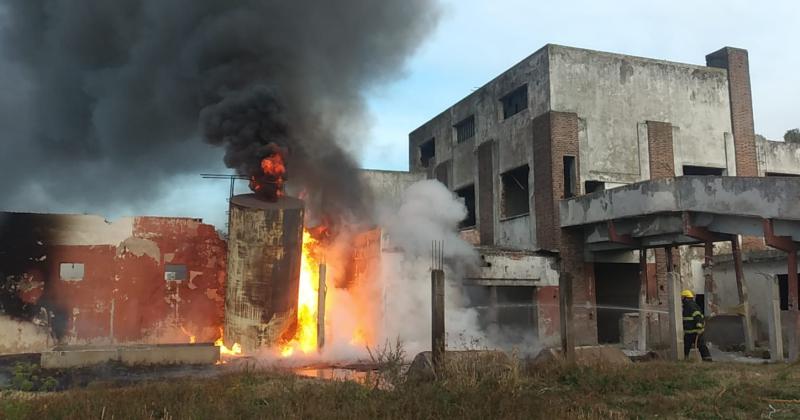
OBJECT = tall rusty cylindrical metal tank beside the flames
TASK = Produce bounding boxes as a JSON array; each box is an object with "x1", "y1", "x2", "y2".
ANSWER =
[{"x1": 224, "y1": 194, "x2": 304, "y2": 352}]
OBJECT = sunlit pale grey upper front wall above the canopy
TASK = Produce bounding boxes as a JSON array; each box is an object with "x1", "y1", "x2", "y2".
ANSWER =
[{"x1": 549, "y1": 46, "x2": 732, "y2": 183}]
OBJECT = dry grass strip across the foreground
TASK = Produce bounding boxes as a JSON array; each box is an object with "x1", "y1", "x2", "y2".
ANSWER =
[{"x1": 0, "y1": 360, "x2": 800, "y2": 420}]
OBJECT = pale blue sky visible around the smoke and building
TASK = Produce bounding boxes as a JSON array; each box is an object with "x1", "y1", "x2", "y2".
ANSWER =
[{"x1": 3, "y1": 0, "x2": 800, "y2": 229}]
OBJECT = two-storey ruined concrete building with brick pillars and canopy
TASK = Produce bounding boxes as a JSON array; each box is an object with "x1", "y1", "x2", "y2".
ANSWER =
[{"x1": 409, "y1": 45, "x2": 800, "y2": 358}]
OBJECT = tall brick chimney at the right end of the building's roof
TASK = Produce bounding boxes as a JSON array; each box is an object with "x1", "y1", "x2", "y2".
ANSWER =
[{"x1": 706, "y1": 47, "x2": 758, "y2": 176}]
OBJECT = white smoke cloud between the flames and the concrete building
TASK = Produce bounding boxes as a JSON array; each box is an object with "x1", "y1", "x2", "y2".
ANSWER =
[{"x1": 377, "y1": 180, "x2": 484, "y2": 356}]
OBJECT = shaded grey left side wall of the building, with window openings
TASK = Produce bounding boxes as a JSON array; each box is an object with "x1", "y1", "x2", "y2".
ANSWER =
[{"x1": 409, "y1": 47, "x2": 550, "y2": 249}]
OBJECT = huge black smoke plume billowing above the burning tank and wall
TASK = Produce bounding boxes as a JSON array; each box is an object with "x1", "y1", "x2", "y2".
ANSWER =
[{"x1": 0, "y1": 0, "x2": 438, "y2": 221}]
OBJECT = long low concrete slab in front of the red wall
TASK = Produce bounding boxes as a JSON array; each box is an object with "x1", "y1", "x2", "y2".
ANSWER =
[{"x1": 40, "y1": 343, "x2": 219, "y2": 369}]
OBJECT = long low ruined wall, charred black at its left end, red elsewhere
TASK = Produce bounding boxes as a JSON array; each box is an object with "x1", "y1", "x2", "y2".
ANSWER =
[{"x1": 0, "y1": 213, "x2": 226, "y2": 352}]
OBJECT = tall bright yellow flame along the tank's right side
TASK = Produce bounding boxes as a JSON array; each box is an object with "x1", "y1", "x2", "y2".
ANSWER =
[{"x1": 281, "y1": 229, "x2": 321, "y2": 357}]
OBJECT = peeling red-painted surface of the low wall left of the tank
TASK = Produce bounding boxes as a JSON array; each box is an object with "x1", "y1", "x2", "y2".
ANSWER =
[{"x1": 29, "y1": 217, "x2": 227, "y2": 343}]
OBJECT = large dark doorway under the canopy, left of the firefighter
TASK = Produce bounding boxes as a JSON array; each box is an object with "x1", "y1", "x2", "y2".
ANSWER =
[{"x1": 594, "y1": 263, "x2": 640, "y2": 343}]
